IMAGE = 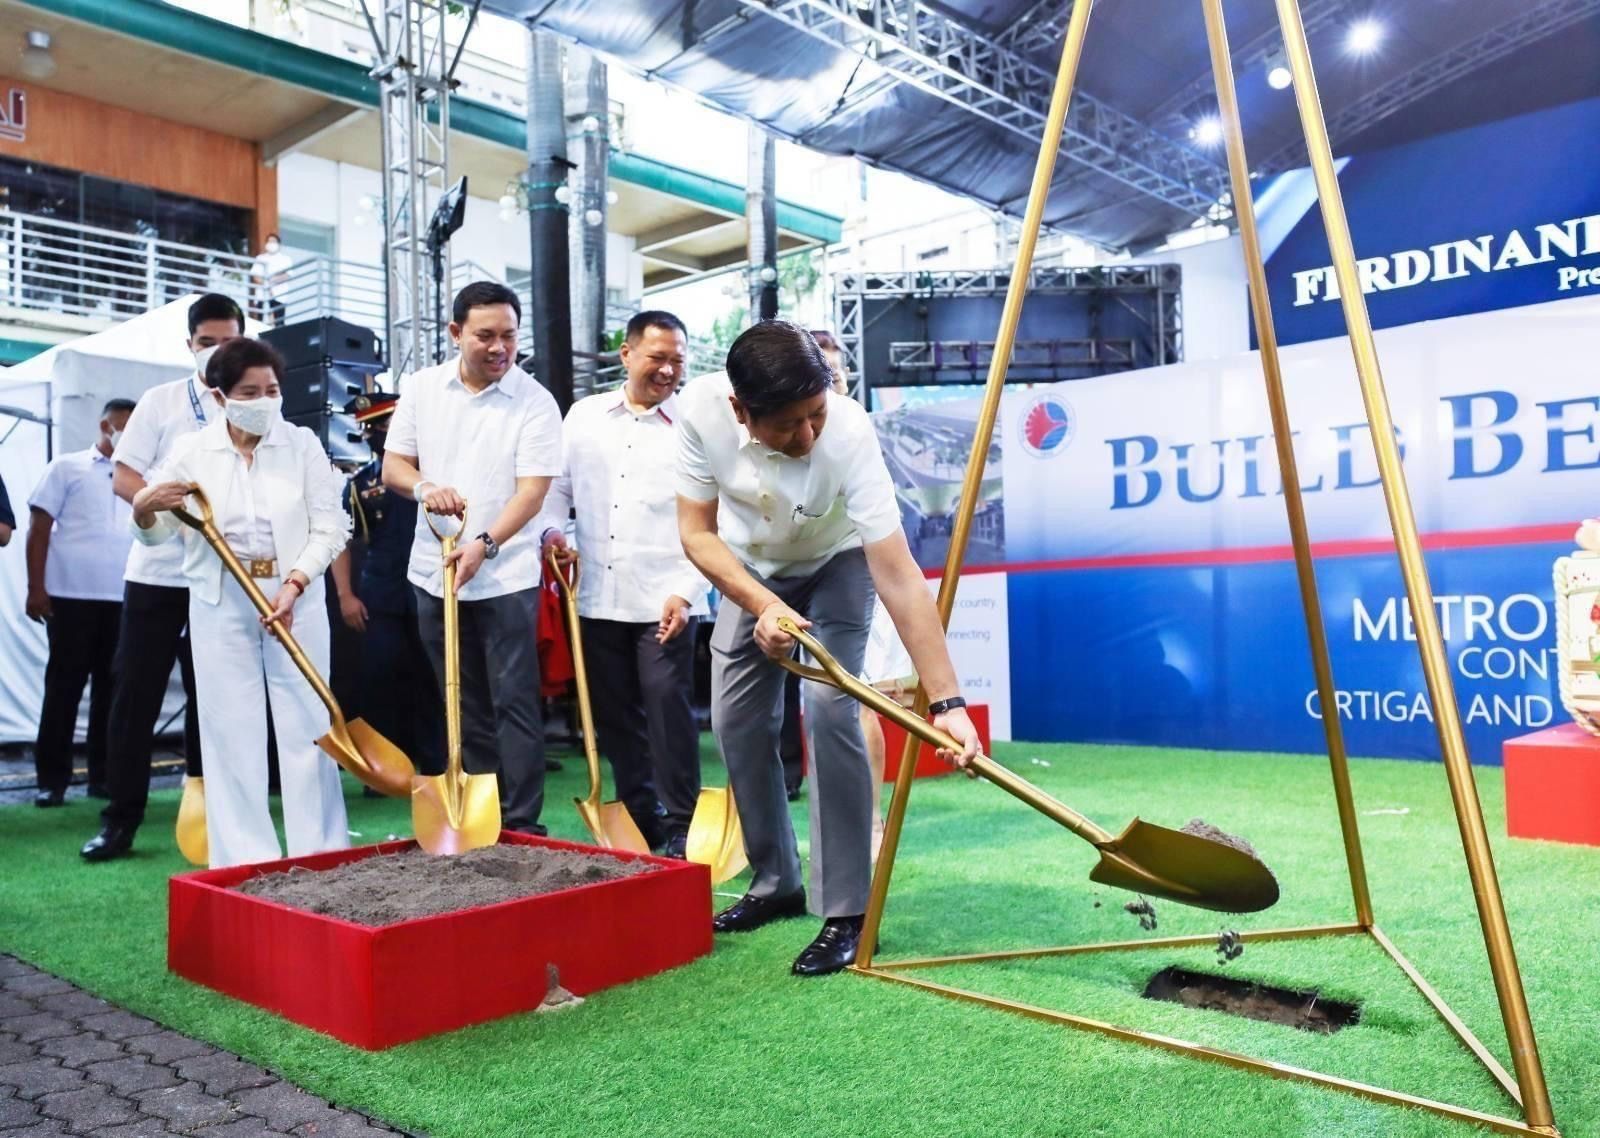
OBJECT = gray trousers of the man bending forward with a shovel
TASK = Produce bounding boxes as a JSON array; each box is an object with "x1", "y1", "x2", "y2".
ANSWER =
[{"x1": 710, "y1": 549, "x2": 874, "y2": 917}]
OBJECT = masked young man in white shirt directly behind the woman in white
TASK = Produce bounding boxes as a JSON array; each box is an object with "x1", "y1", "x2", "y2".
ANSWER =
[{"x1": 80, "y1": 293, "x2": 245, "y2": 861}]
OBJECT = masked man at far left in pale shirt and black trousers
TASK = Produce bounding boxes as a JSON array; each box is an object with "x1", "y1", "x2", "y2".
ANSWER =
[{"x1": 27, "y1": 399, "x2": 134, "y2": 807}]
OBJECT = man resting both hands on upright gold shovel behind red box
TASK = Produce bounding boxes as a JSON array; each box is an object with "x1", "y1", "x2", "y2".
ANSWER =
[{"x1": 384, "y1": 280, "x2": 562, "y2": 834}]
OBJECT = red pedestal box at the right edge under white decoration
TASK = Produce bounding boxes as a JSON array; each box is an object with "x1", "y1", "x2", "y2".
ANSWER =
[{"x1": 1501, "y1": 723, "x2": 1600, "y2": 845}]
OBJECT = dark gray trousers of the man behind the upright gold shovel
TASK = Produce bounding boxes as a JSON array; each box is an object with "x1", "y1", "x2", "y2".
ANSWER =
[{"x1": 411, "y1": 586, "x2": 544, "y2": 834}]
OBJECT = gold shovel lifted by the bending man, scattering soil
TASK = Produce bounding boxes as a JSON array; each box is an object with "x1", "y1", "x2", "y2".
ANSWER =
[{"x1": 778, "y1": 616, "x2": 1278, "y2": 912}]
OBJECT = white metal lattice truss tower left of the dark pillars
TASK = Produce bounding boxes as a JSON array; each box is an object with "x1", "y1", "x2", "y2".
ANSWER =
[{"x1": 362, "y1": 0, "x2": 464, "y2": 379}]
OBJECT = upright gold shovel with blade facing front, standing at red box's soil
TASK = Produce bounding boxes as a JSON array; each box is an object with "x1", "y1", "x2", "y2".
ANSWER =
[{"x1": 411, "y1": 506, "x2": 501, "y2": 855}]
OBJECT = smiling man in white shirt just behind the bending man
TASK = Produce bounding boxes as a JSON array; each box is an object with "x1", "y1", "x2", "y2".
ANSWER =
[{"x1": 541, "y1": 312, "x2": 707, "y2": 858}]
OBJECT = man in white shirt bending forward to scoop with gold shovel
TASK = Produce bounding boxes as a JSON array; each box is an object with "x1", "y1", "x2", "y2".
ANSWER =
[{"x1": 678, "y1": 320, "x2": 978, "y2": 976}]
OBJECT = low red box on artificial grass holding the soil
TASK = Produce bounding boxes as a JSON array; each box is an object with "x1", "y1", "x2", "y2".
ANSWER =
[{"x1": 166, "y1": 832, "x2": 712, "y2": 1050}]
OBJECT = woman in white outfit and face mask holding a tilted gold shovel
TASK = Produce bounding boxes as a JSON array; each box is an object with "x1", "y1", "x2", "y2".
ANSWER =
[{"x1": 133, "y1": 339, "x2": 350, "y2": 868}]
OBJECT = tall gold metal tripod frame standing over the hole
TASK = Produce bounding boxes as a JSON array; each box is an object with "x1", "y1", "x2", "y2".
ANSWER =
[{"x1": 853, "y1": 0, "x2": 1557, "y2": 1135}]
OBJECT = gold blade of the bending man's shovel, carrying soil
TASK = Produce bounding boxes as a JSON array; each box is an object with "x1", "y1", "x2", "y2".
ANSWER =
[{"x1": 1090, "y1": 818, "x2": 1278, "y2": 912}]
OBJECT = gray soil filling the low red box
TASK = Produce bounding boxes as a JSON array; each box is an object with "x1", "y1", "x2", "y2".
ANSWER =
[{"x1": 237, "y1": 845, "x2": 658, "y2": 925}]
